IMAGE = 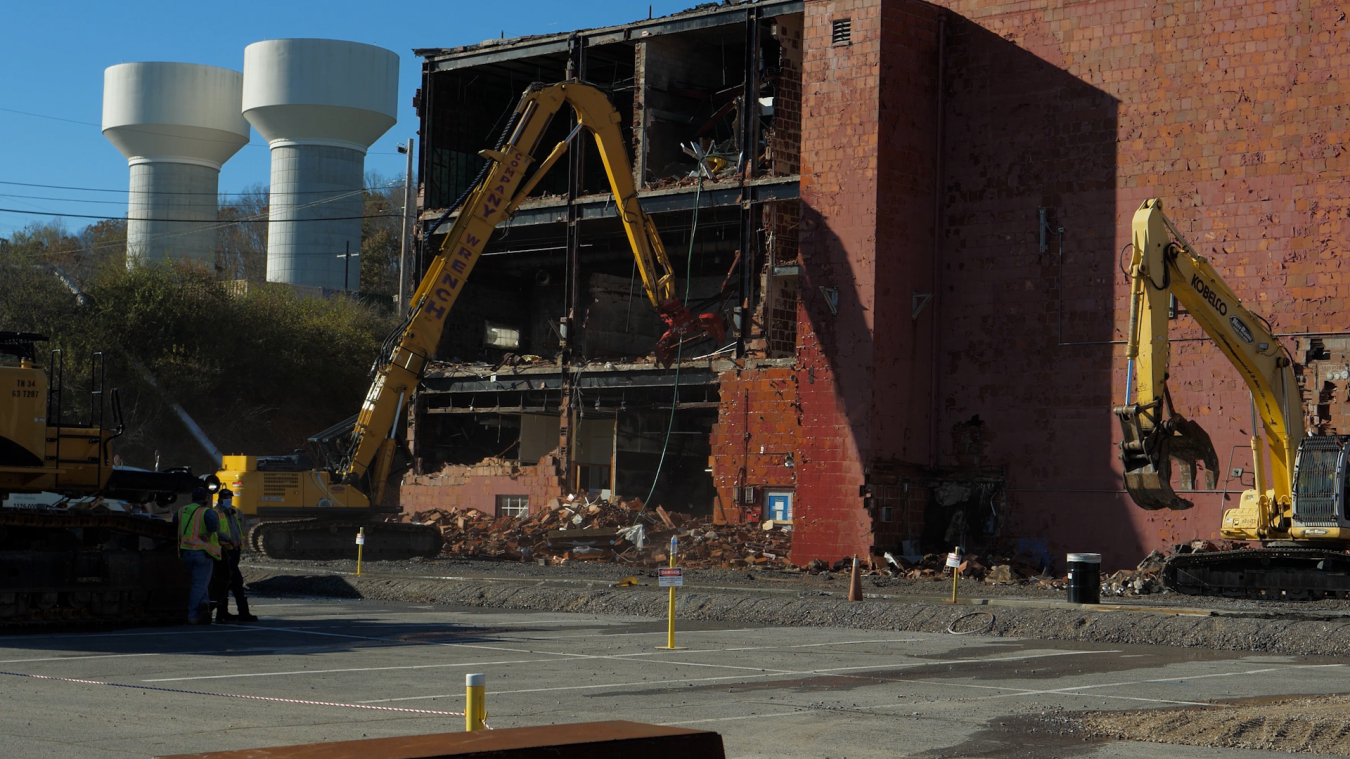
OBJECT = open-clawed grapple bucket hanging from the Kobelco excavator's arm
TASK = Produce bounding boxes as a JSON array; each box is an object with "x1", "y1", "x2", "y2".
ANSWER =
[{"x1": 1115, "y1": 404, "x2": 1219, "y2": 511}]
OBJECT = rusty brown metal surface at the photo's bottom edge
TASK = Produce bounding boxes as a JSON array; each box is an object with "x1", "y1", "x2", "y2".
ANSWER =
[{"x1": 157, "y1": 721, "x2": 726, "y2": 759}]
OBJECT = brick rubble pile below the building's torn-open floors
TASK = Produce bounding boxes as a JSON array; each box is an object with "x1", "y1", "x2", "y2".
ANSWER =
[{"x1": 400, "y1": 500, "x2": 791, "y2": 569}]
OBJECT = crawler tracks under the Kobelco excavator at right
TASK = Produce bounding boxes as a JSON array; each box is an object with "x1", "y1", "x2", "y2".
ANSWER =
[{"x1": 1162, "y1": 547, "x2": 1350, "y2": 601}]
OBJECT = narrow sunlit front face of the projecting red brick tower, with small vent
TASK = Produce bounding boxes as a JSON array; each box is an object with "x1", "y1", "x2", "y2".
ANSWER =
[{"x1": 791, "y1": 0, "x2": 882, "y2": 565}]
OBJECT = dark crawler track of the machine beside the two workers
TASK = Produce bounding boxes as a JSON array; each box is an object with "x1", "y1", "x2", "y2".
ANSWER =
[{"x1": 0, "y1": 509, "x2": 189, "y2": 629}]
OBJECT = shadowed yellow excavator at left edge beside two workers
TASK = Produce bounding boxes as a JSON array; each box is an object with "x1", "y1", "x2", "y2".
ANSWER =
[{"x1": 0, "y1": 332, "x2": 213, "y2": 628}]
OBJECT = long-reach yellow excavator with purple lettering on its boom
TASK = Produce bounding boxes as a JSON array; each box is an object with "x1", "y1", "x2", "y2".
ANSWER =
[{"x1": 219, "y1": 81, "x2": 724, "y2": 559}]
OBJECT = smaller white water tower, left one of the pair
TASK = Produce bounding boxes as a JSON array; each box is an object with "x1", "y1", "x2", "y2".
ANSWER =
[{"x1": 103, "y1": 62, "x2": 248, "y2": 266}]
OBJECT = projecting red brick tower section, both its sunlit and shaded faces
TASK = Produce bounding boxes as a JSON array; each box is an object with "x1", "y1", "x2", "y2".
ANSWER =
[{"x1": 792, "y1": 0, "x2": 937, "y2": 563}]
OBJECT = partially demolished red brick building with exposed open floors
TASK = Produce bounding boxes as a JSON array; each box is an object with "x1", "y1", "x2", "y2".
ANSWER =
[{"x1": 401, "y1": 0, "x2": 1350, "y2": 569}]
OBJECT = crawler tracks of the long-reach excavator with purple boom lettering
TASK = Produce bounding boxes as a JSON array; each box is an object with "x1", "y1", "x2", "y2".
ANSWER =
[{"x1": 248, "y1": 517, "x2": 443, "y2": 562}]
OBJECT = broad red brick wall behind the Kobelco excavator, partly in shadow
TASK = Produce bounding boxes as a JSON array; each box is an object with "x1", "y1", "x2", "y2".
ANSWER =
[{"x1": 940, "y1": 0, "x2": 1350, "y2": 569}]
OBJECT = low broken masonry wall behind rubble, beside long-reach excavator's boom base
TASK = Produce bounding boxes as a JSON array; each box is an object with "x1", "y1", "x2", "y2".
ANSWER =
[{"x1": 398, "y1": 455, "x2": 562, "y2": 516}]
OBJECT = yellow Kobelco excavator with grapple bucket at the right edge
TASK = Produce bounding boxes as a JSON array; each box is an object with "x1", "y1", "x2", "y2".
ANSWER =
[{"x1": 1115, "y1": 200, "x2": 1350, "y2": 600}]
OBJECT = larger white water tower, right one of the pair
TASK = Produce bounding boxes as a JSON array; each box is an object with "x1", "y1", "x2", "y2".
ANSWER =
[{"x1": 243, "y1": 39, "x2": 398, "y2": 290}]
